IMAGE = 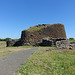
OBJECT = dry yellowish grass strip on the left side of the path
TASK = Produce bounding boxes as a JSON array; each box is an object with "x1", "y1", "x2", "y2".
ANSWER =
[{"x1": 0, "y1": 41, "x2": 32, "y2": 57}]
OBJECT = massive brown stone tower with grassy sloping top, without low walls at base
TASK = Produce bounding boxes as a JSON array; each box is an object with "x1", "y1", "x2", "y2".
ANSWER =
[{"x1": 21, "y1": 23, "x2": 66, "y2": 45}]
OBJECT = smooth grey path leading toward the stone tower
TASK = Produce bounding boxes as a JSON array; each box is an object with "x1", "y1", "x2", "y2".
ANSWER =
[{"x1": 0, "y1": 48, "x2": 38, "y2": 75}]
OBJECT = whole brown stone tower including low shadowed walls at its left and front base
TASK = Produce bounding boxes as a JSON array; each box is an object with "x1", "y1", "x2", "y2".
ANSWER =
[{"x1": 7, "y1": 23, "x2": 66, "y2": 46}]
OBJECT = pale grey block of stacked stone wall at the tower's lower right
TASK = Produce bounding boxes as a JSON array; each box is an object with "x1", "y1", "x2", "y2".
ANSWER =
[{"x1": 56, "y1": 40, "x2": 69, "y2": 49}]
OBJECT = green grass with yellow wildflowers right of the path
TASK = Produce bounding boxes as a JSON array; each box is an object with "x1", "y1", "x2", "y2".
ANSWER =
[{"x1": 16, "y1": 47, "x2": 75, "y2": 75}]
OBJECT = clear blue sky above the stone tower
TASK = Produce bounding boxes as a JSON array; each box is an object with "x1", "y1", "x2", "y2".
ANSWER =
[{"x1": 0, "y1": 0, "x2": 75, "y2": 39}]
